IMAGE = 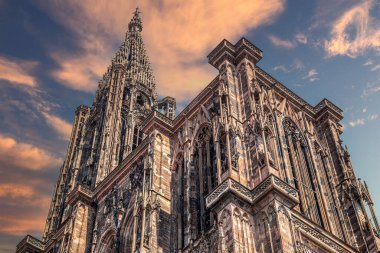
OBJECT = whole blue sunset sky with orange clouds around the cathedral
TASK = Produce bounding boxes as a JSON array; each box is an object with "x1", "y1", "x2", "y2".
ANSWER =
[{"x1": 0, "y1": 0, "x2": 380, "y2": 253}]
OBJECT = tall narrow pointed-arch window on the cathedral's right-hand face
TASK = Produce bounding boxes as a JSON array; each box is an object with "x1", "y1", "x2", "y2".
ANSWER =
[{"x1": 283, "y1": 118, "x2": 324, "y2": 226}]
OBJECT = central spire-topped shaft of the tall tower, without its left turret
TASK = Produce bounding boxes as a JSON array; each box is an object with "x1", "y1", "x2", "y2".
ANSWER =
[{"x1": 82, "y1": 9, "x2": 157, "y2": 186}]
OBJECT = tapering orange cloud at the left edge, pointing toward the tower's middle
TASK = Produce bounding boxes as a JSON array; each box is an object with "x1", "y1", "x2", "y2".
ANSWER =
[{"x1": 0, "y1": 134, "x2": 62, "y2": 171}]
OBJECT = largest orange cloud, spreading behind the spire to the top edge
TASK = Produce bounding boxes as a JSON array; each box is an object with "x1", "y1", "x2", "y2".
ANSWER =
[{"x1": 40, "y1": 0, "x2": 285, "y2": 100}]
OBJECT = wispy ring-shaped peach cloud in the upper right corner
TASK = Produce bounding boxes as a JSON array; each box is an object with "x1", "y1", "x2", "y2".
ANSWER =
[{"x1": 324, "y1": 0, "x2": 380, "y2": 58}]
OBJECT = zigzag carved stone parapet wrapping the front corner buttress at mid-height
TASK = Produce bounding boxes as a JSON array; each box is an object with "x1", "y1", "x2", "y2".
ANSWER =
[{"x1": 206, "y1": 175, "x2": 298, "y2": 208}]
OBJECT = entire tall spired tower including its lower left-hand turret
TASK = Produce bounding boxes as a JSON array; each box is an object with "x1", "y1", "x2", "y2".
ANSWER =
[{"x1": 44, "y1": 9, "x2": 159, "y2": 243}]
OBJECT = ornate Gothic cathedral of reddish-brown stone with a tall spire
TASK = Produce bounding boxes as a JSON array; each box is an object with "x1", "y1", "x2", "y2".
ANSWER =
[{"x1": 16, "y1": 9, "x2": 380, "y2": 253}]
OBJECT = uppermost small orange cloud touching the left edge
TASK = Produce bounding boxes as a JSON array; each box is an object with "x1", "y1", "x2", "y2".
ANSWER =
[{"x1": 0, "y1": 56, "x2": 38, "y2": 88}]
